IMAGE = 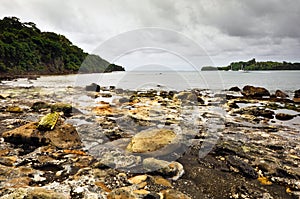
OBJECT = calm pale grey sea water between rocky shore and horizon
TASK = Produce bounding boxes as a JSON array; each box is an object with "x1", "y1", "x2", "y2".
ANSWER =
[{"x1": 2, "y1": 71, "x2": 300, "y2": 91}]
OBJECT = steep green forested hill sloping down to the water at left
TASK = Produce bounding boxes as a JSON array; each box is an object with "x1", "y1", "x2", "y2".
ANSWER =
[{"x1": 0, "y1": 17, "x2": 124, "y2": 75}]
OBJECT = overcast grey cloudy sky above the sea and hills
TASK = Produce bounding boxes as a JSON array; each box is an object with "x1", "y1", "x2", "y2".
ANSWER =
[{"x1": 0, "y1": 0, "x2": 300, "y2": 70}]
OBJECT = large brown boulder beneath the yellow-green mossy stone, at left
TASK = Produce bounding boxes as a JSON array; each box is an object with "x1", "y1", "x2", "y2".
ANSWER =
[{"x1": 2, "y1": 122, "x2": 81, "y2": 149}]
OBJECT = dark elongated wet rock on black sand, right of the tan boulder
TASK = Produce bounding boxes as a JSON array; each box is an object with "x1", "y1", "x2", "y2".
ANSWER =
[{"x1": 227, "y1": 156, "x2": 258, "y2": 179}]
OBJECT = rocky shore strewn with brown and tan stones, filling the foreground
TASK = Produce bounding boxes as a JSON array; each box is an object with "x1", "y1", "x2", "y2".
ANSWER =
[{"x1": 0, "y1": 81, "x2": 300, "y2": 199}]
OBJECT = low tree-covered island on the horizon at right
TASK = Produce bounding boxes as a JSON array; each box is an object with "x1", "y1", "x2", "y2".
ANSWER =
[{"x1": 201, "y1": 58, "x2": 300, "y2": 71}]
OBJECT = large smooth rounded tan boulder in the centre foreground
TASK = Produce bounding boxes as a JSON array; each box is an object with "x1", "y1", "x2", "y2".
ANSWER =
[{"x1": 126, "y1": 129, "x2": 176, "y2": 153}]
